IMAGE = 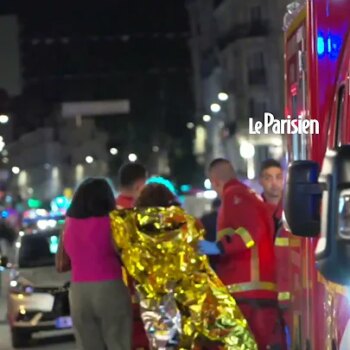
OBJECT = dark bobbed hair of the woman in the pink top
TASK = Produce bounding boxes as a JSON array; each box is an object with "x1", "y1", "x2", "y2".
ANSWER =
[{"x1": 67, "y1": 178, "x2": 115, "y2": 219}]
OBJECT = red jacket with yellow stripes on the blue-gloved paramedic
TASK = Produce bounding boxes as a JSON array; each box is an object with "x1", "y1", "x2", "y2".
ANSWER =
[{"x1": 217, "y1": 180, "x2": 277, "y2": 300}]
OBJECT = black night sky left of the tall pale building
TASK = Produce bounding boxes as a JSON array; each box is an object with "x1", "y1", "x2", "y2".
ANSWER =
[{"x1": 0, "y1": 0, "x2": 200, "y2": 182}]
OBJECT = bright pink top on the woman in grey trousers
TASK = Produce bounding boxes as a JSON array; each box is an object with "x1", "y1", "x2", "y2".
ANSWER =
[{"x1": 63, "y1": 216, "x2": 122, "y2": 282}]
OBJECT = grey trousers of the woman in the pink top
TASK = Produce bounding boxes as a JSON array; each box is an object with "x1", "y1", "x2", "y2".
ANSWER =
[{"x1": 69, "y1": 280, "x2": 132, "y2": 350}]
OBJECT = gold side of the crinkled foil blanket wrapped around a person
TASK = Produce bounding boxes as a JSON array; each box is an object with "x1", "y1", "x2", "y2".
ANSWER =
[{"x1": 111, "y1": 207, "x2": 257, "y2": 350}]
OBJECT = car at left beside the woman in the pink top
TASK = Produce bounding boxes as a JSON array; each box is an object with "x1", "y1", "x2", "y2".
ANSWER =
[{"x1": 0, "y1": 230, "x2": 72, "y2": 348}]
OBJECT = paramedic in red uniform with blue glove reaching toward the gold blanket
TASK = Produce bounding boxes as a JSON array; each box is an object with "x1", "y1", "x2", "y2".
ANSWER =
[{"x1": 199, "y1": 158, "x2": 286, "y2": 350}]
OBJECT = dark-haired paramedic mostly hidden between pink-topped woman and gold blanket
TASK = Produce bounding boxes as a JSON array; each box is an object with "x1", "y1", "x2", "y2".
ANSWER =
[{"x1": 116, "y1": 163, "x2": 149, "y2": 350}]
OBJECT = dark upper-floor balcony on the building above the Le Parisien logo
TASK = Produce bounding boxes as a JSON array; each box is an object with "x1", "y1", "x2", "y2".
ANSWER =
[{"x1": 218, "y1": 21, "x2": 269, "y2": 50}]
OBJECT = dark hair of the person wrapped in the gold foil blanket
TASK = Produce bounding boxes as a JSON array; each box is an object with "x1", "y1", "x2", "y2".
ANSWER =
[{"x1": 135, "y1": 183, "x2": 180, "y2": 208}]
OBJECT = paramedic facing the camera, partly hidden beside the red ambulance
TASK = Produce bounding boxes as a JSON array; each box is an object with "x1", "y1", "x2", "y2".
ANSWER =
[{"x1": 259, "y1": 159, "x2": 292, "y2": 346}]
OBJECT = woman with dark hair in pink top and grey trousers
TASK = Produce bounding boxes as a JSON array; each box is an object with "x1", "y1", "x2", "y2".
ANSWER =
[{"x1": 63, "y1": 178, "x2": 132, "y2": 350}]
